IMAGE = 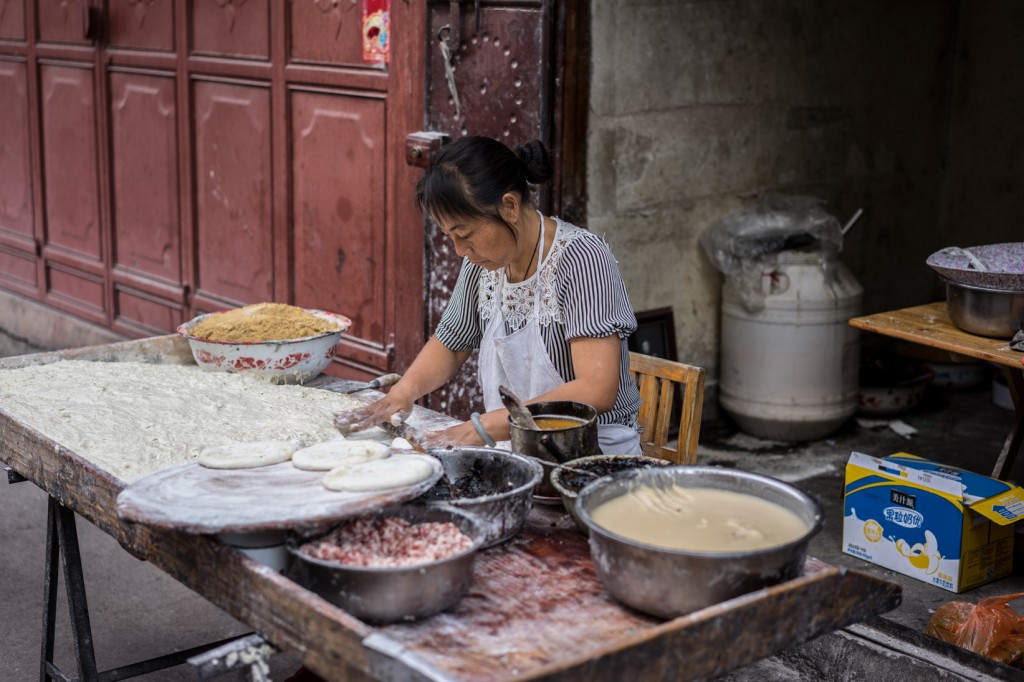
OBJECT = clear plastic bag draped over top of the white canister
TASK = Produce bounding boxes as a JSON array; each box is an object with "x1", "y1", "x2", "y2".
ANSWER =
[{"x1": 700, "y1": 189, "x2": 843, "y2": 312}]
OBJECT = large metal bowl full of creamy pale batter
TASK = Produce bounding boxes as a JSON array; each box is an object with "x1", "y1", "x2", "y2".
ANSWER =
[{"x1": 577, "y1": 466, "x2": 824, "y2": 619}]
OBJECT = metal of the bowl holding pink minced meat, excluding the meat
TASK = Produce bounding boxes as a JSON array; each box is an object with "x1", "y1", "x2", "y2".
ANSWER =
[{"x1": 289, "y1": 505, "x2": 484, "y2": 623}]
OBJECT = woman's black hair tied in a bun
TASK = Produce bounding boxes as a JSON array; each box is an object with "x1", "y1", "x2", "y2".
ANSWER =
[{"x1": 416, "y1": 135, "x2": 552, "y2": 223}]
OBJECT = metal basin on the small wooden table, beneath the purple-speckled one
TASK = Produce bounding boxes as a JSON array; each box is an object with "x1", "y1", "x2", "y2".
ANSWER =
[{"x1": 946, "y1": 280, "x2": 1024, "y2": 339}]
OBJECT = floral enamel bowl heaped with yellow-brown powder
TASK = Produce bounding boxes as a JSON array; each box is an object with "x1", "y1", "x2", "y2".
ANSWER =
[{"x1": 177, "y1": 303, "x2": 352, "y2": 384}]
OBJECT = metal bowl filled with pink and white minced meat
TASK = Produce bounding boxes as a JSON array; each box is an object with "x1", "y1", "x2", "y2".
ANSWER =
[{"x1": 289, "y1": 505, "x2": 486, "y2": 624}]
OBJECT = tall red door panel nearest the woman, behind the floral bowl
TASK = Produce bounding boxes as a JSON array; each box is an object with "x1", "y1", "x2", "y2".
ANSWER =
[{"x1": 291, "y1": 92, "x2": 385, "y2": 350}]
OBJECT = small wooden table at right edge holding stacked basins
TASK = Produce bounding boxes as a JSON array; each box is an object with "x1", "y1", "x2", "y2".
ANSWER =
[{"x1": 850, "y1": 302, "x2": 1024, "y2": 478}]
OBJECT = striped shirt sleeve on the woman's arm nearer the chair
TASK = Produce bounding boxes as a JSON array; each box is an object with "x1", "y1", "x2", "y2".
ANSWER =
[{"x1": 558, "y1": 233, "x2": 637, "y2": 339}]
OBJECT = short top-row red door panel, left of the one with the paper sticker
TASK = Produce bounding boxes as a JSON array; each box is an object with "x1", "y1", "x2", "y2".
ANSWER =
[{"x1": 190, "y1": 0, "x2": 270, "y2": 59}]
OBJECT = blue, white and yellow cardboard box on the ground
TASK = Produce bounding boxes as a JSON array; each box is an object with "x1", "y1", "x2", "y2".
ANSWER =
[{"x1": 843, "y1": 453, "x2": 1024, "y2": 592}]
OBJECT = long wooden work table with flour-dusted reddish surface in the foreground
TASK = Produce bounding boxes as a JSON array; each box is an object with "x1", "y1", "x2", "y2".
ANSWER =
[{"x1": 0, "y1": 337, "x2": 900, "y2": 682}]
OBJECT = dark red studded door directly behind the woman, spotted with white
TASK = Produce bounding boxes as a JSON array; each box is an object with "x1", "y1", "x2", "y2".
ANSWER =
[{"x1": 419, "y1": 0, "x2": 588, "y2": 418}]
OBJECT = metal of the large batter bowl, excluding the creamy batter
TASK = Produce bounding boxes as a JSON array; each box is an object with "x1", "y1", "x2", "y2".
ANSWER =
[{"x1": 577, "y1": 466, "x2": 823, "y2": 619}]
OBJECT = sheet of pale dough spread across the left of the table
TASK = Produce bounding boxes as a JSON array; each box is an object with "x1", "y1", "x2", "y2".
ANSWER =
[{"x1": 0, "y1": 360, "x2": 362, "y2": 483}]
